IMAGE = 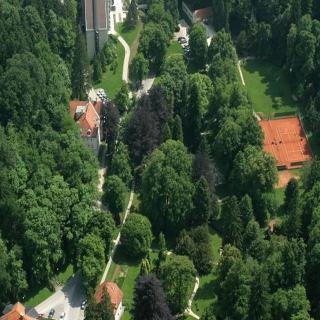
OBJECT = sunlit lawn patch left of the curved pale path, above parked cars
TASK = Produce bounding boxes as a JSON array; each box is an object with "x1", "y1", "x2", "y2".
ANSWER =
[{"x1": 94, "y1": 41, "x2": 124, "y2": 99}]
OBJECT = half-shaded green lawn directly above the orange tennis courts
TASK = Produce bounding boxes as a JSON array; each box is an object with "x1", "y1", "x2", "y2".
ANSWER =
[{"x1": 242, "y1": 59, "x2": 298, "y2": 116}]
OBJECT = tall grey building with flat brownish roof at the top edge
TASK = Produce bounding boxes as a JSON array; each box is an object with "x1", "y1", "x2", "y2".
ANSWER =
[{"x1": 83, "y1": 0, "x2": 112, "y2": 60}]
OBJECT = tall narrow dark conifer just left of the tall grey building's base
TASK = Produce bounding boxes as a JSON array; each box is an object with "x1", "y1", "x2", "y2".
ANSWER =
[{"x1": 71, "y1": 29, "x2": 91, "y2": 100}]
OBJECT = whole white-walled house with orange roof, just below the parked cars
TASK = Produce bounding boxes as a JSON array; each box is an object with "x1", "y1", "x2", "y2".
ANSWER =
[{"x1": 69, "y1": 100, "x2": 102, "y2": 156}]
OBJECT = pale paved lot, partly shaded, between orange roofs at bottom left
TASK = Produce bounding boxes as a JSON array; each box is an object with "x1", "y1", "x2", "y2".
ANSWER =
[{"x1": 35, "y1": 273, "x2": 85, "y2": 320}]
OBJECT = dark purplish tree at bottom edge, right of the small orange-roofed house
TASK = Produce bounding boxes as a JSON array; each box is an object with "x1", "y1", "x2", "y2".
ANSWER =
[{"x1": 132, "y1": 275, "x2": 172, "y2": 320}]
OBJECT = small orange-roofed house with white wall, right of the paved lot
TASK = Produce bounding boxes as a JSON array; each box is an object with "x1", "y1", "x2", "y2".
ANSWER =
[{"x1": 95, "y1": 281, "x2": 124, "y2": 320}]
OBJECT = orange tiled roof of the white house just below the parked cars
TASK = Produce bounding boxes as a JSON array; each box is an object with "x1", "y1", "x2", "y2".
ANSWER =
[{"x1": 69, "y1": 100, "x2": 102, "y2": 137}]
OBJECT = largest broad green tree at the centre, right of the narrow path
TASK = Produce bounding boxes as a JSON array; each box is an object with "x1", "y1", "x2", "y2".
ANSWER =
[{"x1": 141, "y1": 140, "x2": 194, "y2": 233}]
